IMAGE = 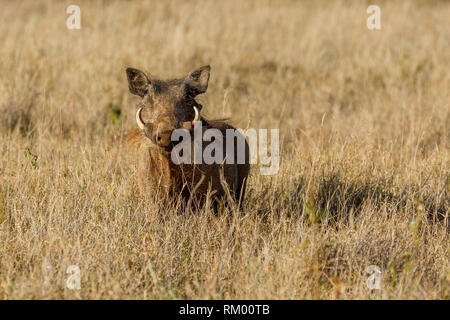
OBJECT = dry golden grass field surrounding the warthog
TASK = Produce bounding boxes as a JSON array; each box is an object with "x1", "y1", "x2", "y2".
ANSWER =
[{"x1": 0, "y1": 0, "x2": 450, "y2": 299}]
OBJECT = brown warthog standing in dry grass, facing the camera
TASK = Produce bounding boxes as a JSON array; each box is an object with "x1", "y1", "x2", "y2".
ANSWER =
[{"x1": 126, "y1": 66, "x2": 250, "y2": 210}]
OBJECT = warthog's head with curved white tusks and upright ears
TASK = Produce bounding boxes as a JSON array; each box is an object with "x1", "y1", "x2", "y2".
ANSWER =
[{"x1": 127, "y1": 66, "x2": 210, "y2": 151}]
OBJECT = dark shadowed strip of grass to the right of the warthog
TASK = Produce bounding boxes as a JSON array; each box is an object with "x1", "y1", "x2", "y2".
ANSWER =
[{"x1": 258, "y1": 174, "x2": 449, "y2": 223}]
